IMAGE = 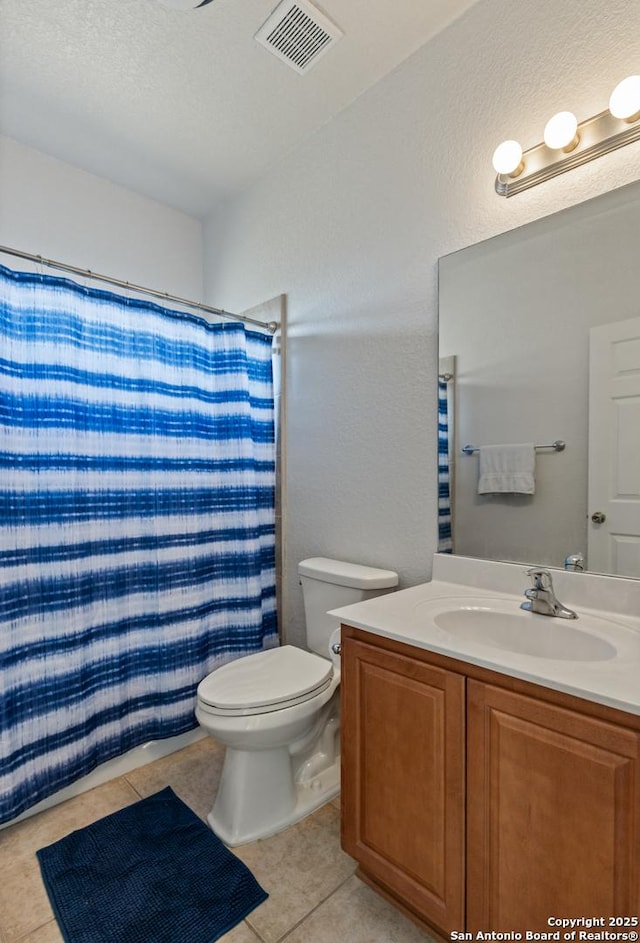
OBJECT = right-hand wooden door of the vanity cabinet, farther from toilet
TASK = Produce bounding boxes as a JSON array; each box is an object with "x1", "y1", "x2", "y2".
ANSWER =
[{"x1": 467, "y1": 680, "x2": 640, "y2": 932}]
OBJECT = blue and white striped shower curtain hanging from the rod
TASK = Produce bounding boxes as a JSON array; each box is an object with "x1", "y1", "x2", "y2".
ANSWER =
[{"x1": 0, "y1": 266, "x2": 277, "y2": 822}]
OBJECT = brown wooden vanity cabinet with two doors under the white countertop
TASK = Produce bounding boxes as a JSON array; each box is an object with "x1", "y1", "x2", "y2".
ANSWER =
[{"x1": 342, "y1": 626, "x2": 640, "y2": 935}]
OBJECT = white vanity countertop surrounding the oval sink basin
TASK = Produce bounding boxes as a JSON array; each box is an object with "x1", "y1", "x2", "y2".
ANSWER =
[{"x1": 330, "y1": 563, "x2": 640, "y2": 715}]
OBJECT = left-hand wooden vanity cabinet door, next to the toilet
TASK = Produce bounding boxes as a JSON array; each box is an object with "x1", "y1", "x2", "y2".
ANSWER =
[{"x1": 341, "y1": 629, "x2": 465, "y2": 933}]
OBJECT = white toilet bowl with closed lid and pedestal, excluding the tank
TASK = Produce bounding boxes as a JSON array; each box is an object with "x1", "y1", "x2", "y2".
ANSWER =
[{"x1": 196, "y1": 629, "x2": 340, "y2": 845}]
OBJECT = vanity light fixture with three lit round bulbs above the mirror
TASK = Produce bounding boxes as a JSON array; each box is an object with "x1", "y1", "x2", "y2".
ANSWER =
[{"x1": 493, "y1": 75, "x2": 640, "y2": 197}]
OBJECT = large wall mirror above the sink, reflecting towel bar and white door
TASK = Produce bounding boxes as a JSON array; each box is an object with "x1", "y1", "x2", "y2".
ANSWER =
[{"x1": 439, "y1": 175, "x2": 640, "y2": 579}]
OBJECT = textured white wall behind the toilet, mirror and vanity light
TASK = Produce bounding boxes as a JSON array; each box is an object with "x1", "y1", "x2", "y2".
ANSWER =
[{"x1": 205, "y1": 0, "x2": 640, "y2": 641}]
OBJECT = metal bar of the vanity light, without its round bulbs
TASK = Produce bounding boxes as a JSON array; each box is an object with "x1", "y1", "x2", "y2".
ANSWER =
[{"x1": 496, "y1": 110, "x2": 640, "y2": 197}]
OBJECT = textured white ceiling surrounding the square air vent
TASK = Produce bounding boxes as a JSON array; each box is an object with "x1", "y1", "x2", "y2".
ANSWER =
[{"x1": 0, "y1": 0, "x2": 475, "y2": 217}]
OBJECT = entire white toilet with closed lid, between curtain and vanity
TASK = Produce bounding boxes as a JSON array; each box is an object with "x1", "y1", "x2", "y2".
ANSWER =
[{"x1": 196, "y1": 557, "x2": 398, "y2": 845}]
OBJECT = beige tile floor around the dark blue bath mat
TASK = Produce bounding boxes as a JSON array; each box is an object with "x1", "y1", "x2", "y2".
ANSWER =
[{"x1": 0, "y1": 737, "x2": 431, "y2": 943}]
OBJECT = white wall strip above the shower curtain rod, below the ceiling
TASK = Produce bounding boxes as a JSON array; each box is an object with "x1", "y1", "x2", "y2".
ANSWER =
[{"x1": 0, "y1": 138, "x2": 203, "y2": 301}]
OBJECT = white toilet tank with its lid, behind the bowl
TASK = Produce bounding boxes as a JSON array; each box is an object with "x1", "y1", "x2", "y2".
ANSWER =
[{"x1": 298, "y1": 557, "x2": 398, "y2": 658}]
